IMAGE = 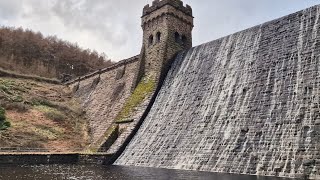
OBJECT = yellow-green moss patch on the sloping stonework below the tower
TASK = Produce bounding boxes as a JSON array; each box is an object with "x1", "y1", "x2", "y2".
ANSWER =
[{"x1": 116, "y1": 77, "x2": 156, "y2": 123}]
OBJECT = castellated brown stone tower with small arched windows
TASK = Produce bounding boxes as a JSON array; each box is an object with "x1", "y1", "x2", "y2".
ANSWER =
[{"x1": 140, "y1": 0, "x2": 193, "y2": 79}]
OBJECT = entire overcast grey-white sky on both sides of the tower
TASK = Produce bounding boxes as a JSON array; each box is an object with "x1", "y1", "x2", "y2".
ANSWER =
[{"x1": 0, "y1": 0, "x2": 320, "y2": 61}]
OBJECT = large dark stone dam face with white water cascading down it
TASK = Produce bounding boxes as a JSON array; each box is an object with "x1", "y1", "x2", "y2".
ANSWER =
[{"x1": 115, "y1": 6, "x2": 320, "y2": 179}]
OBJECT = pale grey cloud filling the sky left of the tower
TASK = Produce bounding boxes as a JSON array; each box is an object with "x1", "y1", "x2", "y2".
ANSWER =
[{"x1": 0, "y1": 0, "x2": 148, "y2": 59}]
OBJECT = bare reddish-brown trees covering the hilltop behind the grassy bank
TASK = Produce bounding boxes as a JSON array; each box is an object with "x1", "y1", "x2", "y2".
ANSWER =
[{"x1": 0, "y1": 27, "x2": 113, "y2": 78}]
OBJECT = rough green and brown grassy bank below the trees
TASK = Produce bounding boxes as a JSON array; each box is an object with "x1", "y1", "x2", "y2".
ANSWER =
[{"x1": 0, "y1": 78, "x2": 89, "y2": 152}]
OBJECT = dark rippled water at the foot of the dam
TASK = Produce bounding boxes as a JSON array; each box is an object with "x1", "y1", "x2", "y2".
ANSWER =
[{"x1": 0, "y1": 165, "x2": 292, "y2": 180}]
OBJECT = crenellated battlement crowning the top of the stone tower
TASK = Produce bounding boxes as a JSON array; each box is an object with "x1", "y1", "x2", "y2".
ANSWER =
[{"x1": 142, "y1": 0, "x2": 192, "y2": 16}]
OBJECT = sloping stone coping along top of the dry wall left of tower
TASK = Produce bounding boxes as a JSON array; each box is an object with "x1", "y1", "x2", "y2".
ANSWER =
[{"x1": 65, "y1": 55, "x2": 140, "y2": 85}]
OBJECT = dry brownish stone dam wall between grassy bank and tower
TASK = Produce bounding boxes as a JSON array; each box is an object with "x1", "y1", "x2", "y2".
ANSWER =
[{"x1": 67, "y1": 56, "x2": 139, "y2": 144}]
